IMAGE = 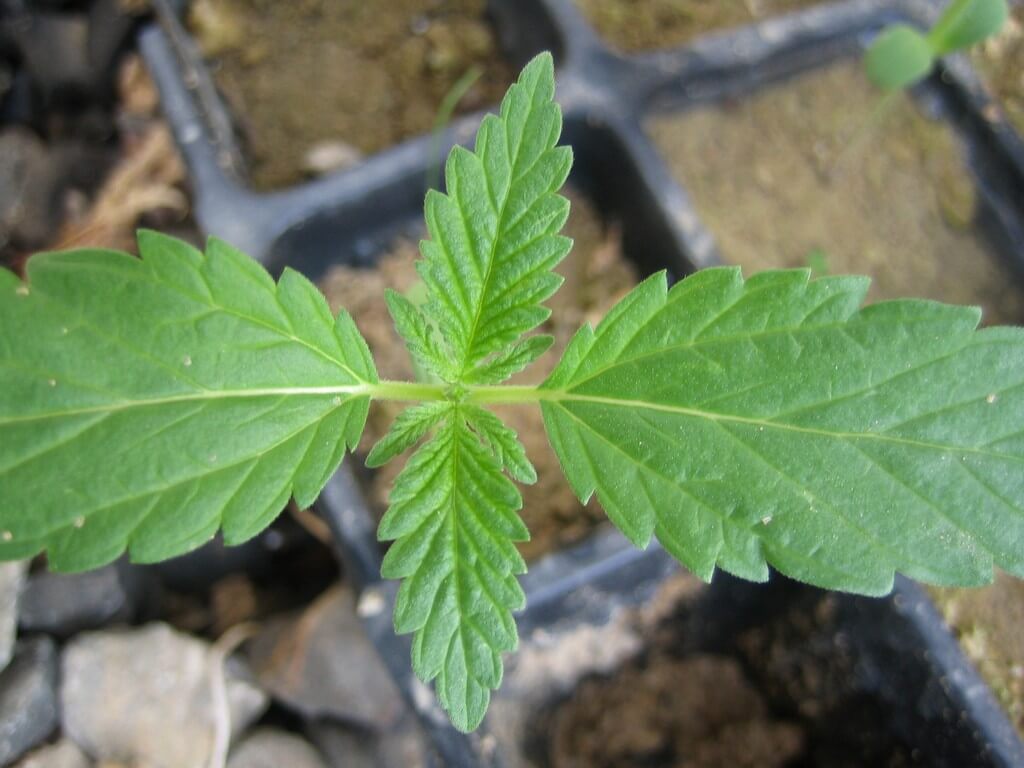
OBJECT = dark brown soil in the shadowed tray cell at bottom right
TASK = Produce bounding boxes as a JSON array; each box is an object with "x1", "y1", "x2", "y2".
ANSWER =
[{"x1": 536, "y1": 591, "x2": 921, "y2": 768}]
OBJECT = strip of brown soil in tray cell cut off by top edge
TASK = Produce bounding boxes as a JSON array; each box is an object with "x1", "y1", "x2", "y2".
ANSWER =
[{"x1": 575, "y1": 0, "x2": 822, "y2": 53}]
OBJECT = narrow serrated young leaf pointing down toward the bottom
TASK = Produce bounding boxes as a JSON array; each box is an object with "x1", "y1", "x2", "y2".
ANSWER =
[{"x1": 378, "y1": 403, "x2": 528, "y2": 731}]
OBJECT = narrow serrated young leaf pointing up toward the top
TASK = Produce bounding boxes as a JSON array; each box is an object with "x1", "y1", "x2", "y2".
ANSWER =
[{"x1": 418, "y1": 53, "x2": 572, "y2": 382}]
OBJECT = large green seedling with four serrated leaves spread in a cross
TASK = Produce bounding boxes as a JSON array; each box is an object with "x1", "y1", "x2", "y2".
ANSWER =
[{"x1": 0, "y1": 54, "x2": 1024, "y2": 730}]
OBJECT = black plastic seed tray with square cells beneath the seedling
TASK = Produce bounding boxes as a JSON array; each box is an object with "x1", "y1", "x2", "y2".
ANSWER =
[{"x1": 141, "y1": 0, "x2": 1024, "y2": 766}]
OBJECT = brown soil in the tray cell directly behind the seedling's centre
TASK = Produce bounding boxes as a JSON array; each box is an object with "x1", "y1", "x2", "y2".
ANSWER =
[{"x1": 321, "y1": 186, "x2": 637, "y2": 559}]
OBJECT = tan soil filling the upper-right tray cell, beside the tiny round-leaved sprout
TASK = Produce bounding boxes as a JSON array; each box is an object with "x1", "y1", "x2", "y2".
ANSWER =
[{"x1": 648, "y1": 61, "x2": 1024, "y2": 324}]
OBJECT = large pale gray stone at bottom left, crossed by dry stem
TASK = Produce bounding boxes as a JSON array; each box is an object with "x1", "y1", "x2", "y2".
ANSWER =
[{"x1": 60, "y1": 624, "x2": 267, "y2": 768}]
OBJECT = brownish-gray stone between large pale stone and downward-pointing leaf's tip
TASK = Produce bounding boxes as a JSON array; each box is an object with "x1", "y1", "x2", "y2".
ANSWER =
[{"x1": 250, "y1": 587, "x2": 403, "y2": 728}]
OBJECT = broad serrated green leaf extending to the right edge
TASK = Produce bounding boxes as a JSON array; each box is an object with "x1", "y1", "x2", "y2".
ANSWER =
[{"x1": 542, "y1": 268, "x2": 1024, "y2": 594}]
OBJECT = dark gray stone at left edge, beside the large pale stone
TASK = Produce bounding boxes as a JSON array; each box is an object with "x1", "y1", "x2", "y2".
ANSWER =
[{"x1": 0, "y1": 637, "x2": 57, "y2": 765}]
